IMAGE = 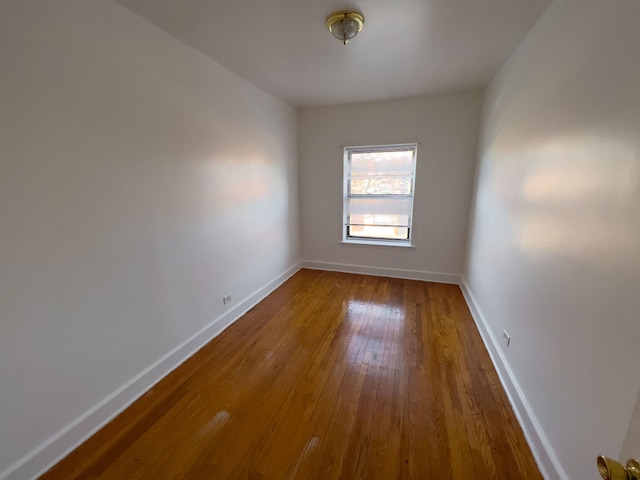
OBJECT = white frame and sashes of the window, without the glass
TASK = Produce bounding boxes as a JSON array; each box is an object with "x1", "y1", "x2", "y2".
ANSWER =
[{"x1": 342, "y1": 143, "x2": 418, "y2": 247}]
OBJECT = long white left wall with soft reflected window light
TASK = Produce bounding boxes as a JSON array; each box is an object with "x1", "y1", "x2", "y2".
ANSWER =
[{"x1": 0, "y1": 0, "x2": 300, "y2": 478}]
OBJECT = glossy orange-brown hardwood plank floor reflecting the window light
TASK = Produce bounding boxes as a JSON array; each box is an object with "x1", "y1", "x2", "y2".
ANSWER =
[{"x1": 41, "y1": 270, "x2": 542, "y2": 480}]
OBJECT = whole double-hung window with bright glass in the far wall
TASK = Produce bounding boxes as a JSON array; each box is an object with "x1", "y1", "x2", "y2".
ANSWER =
[{"x1": 343, "y1": 143, "x2": 418, "y2": 245}]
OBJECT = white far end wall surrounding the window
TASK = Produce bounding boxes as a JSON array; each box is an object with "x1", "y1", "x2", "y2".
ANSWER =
[{"x1": 299, "y1": 93, "x2": 482, "y2": 281}]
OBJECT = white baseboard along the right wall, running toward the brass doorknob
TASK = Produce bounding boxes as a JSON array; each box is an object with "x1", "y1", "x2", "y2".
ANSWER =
[{"x1": 460, "y1": 279, "x2": 569, "y2": 480}]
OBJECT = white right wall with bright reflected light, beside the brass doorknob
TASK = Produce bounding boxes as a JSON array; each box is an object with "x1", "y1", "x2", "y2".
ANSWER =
[{"x1": 465, "y1": 0, "x2": 640, "y2": 479}]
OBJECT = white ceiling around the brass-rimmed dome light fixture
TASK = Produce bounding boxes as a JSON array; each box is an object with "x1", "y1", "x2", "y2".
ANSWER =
[{"x1": 117, "y1": 0, "x2": 551, "y2": 107}]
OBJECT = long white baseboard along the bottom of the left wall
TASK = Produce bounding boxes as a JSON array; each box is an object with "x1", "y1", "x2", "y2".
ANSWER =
[{"x1": 0, "y1": 262, "x2": 301, "y2": 480}]
